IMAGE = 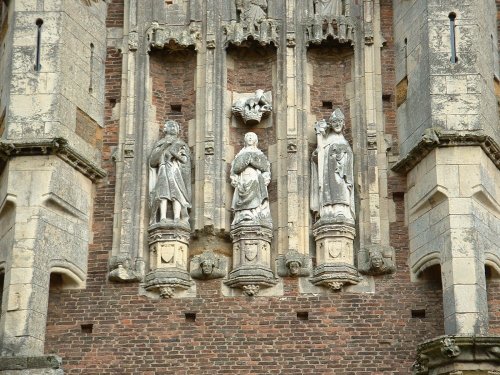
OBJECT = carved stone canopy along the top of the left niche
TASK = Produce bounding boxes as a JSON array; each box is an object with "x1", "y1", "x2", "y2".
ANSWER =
[{"x1": 146, "y1": 22, "x2": 200, "y2": 50}]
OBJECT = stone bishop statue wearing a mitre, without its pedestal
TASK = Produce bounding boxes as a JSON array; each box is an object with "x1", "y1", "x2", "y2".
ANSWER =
[{"x1": 310, "y1": 108, "x2": 355, "y2": 223}]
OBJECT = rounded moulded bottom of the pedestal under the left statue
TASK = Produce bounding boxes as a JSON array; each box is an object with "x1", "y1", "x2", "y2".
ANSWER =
[{"x1": 144, "y1": 267, "x2": 192, "y2": 298}]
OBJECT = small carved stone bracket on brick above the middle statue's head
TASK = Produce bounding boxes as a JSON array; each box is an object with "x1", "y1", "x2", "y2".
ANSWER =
[{"x1": 231, "y1": 90, "x2": 273, "y2": 126}]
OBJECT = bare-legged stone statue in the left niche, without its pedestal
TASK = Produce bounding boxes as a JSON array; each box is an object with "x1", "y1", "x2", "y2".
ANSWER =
[{"x1": 149, "y1": 120, "x2": 191, "y2": 225}]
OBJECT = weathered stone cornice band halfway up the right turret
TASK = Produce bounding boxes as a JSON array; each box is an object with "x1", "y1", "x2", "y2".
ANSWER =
[{"x1": 391, "y1": 128, "x2": 500, "y2": 174}]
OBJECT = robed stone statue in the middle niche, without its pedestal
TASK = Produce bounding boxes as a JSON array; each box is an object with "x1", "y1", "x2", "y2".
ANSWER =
[{"x1": 230, "y1": 132, "x2": 271, "y2": 226}]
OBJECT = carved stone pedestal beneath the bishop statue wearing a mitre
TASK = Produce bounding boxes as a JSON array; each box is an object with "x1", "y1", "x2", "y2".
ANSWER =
[{"x1": 311, "y1": 222, "x2": 361, "y2": 290}]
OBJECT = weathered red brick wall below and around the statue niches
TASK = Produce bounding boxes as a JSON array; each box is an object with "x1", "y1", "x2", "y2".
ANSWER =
[{"x1": 45, "y1": 1, "x2": 452, "y2": 375}]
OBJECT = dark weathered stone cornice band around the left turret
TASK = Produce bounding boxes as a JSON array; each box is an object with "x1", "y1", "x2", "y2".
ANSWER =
[{"x1": 0, "y1": 138, "x2": 106, "y2": 182}]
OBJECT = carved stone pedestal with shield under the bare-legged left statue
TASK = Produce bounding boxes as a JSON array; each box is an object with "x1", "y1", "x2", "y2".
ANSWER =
[{"x1": 144, "y1": 223, "x2": 192, "y2": 298}]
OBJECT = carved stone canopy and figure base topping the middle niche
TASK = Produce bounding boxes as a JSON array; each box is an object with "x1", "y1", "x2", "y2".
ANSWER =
[{"x1": 224, "y1": 0, "x2": 278, "y2": 46}]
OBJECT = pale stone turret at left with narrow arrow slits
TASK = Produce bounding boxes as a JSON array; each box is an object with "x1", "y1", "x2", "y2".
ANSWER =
[{"x1": 0, "y1": 0, "x2": 107, "y2": 369}]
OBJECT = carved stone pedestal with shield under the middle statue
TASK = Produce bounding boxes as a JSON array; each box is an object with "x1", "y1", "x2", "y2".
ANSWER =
[{"x1": 224, "y1": 225, "x2": 278, "y2": 296}]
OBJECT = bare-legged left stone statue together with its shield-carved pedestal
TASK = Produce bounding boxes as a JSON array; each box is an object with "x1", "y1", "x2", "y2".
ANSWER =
[{"x1": 145, "y1": 120, "x2": 192, "y2": 298}]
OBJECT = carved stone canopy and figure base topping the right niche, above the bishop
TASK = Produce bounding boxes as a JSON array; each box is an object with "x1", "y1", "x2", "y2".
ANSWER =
[{"x1": 305, "y1": 0, "x2": 354, "y2": 45}]
